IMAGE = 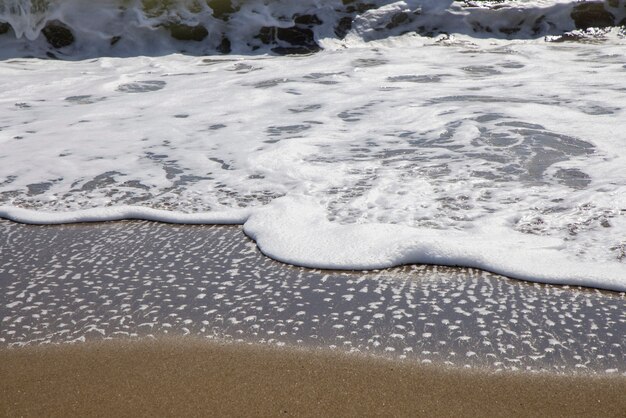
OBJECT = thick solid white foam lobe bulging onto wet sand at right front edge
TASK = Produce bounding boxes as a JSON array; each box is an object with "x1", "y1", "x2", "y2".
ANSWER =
[{"x1": 244, "y1": 198, "x2": 626, "y2": 291}]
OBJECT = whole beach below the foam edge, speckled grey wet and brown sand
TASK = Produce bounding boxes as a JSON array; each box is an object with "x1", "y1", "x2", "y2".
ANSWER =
[{"x1": 0, "y1": 221, "x2": 626, "y2": 416}]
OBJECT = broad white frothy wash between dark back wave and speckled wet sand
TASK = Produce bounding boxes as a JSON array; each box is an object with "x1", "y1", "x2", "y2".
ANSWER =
[{"x1": 0, "y1": 35, "x2": 626, "y2": 290}]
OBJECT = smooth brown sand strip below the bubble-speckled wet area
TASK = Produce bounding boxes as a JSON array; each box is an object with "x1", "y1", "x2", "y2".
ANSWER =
[{"x1": 0, "y1": 339, "x2": 626, "y2": 417}]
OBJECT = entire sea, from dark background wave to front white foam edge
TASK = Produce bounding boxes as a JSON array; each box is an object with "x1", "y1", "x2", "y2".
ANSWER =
[{"x1": 0, "y1": 0, "x2": 626, "y2": 291}]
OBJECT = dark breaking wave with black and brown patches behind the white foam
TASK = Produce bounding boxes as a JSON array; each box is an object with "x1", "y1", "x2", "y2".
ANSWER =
[{"x1": 0, "y1": 0, "x2": 626, "y2": 58}]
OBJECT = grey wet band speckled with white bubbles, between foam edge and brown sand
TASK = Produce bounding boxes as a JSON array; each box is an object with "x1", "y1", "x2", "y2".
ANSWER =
[{"x1": 0, "y1": 221, "x2": 626, "y2": 375}]
